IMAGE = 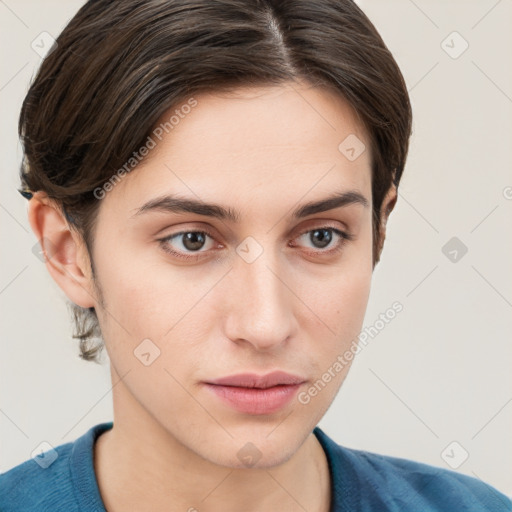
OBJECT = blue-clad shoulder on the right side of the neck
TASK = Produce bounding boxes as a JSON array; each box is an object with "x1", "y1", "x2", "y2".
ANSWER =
[{"x1": 315, "y1": 429, "x2": 512, "y2": 512}]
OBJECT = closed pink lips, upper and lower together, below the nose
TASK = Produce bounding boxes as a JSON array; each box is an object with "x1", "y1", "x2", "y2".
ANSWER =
[{"x1": 205, "y1": 371, "x2": 306, "y2": 415}]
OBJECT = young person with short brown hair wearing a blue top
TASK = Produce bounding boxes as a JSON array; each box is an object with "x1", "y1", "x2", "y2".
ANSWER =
[{"x1": 0, "y1": 0, "x2": 512, "y2": 512}]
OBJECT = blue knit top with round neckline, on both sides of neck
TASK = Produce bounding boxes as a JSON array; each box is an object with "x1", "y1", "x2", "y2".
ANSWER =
[{"x1": 0, "y1": 422, "x2": 512, "y2": 512}]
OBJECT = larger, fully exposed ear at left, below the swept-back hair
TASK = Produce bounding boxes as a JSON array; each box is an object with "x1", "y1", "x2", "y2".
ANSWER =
[{"x1": 28, "y1": 191, "x2": 97, "y2": 308}]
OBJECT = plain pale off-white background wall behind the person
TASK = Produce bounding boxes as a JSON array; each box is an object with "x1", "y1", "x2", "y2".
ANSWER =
[{"x1": 0, "y1": 0, "x2": 512, "y2": 495}]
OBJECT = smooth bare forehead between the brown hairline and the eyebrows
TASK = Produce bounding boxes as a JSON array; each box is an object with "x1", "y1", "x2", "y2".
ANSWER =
[{"x1": 98, "y1": 83, "x2": 371, "y2": 213}]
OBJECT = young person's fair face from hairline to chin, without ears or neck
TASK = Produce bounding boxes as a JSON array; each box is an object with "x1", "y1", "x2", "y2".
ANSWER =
[{"x1": 80, "y1": 80, "x2": 372, "y2": 467}]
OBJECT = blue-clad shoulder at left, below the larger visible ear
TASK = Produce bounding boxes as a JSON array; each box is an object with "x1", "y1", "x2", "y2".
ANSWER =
[{"x1": 0, "y1": 424, "x2": 109, "y2": 512}]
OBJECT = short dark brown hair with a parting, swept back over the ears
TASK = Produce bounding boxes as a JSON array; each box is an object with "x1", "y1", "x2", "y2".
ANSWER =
[{"x1": 19, "y1": 0, "x2": 412, "y2": 361}]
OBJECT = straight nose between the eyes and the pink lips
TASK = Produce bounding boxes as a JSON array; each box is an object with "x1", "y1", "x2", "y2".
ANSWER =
[{"x1": 224, "y1": 244, "x2": 297, "y2": 351}]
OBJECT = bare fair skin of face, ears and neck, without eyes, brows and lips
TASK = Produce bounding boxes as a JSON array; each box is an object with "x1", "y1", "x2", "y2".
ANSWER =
[{"x1": 29, "y1": 83, "x2": 396, "y2": 512}]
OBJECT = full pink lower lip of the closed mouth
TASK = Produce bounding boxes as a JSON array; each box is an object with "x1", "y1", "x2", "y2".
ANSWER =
[{"x1": 206, "y1": 384, "x2": 301, "y2": 414}]
